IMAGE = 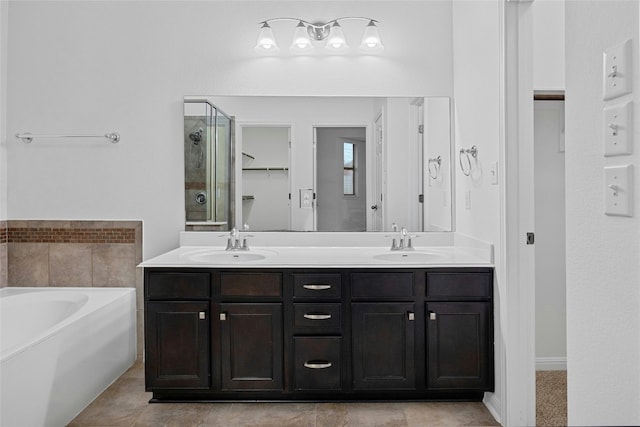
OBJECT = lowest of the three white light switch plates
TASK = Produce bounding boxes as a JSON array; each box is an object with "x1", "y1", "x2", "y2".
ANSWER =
[{"x1": 604, "y1": 165, "x2": 633, "y2": 216}]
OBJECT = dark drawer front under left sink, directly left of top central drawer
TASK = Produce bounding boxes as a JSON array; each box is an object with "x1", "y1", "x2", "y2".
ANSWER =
[{"x1": 220, "y1": 273, "x2": 282, "y2": 297}]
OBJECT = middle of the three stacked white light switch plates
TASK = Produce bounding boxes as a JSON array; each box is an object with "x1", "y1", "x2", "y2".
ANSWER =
[{"x1": 603, "y1": 101, "x2": 633, "y2": 157}]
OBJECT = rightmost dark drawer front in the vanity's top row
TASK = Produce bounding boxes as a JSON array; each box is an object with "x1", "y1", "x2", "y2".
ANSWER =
[{"x1": 427, "y1": 272, "x2": 493, "y2": 299}]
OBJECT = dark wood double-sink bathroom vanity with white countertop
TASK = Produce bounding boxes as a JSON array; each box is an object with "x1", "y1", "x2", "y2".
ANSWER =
[{"x1": 142, "y1": 239, "x2": 494, "y2": 402}]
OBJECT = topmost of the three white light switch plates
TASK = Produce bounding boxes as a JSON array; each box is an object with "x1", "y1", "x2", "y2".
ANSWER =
[{"x1": 602, "y1": 39, "x2": 633, "y2": 101}]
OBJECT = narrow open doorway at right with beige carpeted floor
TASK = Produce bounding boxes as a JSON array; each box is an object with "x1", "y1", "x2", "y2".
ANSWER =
[{"x1": 533, "y1": 96, "x2": 567, "y2": 426}]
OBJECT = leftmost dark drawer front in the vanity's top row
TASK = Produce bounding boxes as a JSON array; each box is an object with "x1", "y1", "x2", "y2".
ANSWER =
[{"x1": 146, "y1": 272, "x2": 211, "y2": 299}]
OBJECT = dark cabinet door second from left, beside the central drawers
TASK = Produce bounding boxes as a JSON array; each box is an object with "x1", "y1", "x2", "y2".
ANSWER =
[{"x1": 220, "y1": 303, "x2": 284, "y2": 390}]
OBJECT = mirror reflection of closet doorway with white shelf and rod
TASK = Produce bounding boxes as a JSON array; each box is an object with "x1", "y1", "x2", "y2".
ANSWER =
[{"x1": 241, "y1": 126, "x2": 291, "y2": 231}]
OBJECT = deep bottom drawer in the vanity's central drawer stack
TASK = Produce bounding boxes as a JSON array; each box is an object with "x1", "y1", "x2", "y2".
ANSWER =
[{"x1": 293, "y1": 337, "x2": 342, "y2": 391}]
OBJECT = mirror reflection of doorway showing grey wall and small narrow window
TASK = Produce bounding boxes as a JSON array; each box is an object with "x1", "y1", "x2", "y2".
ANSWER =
[{"x1": 314, "y1": 127, "x2": 367, "y2": 231}]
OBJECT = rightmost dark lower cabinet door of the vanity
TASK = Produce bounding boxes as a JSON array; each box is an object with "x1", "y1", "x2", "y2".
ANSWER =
[{"x1": 426, "y1": 302, "x2": 493, "y2": 390}]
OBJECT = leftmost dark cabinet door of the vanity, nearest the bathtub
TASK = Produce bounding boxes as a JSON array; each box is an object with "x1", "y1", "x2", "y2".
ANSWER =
[{"x1": 145, "y1": 301, "x2": 210, "y2": 390}]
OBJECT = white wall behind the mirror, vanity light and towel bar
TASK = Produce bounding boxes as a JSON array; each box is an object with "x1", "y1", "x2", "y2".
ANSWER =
[{"x1": 3, "y1": 1, "x2": 452, "y2": 259}]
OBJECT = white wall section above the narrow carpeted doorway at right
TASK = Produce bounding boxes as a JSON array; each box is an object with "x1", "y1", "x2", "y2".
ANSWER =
[{"x1": 531, "y1": 0, "x2": 565, "y2": 91}]
